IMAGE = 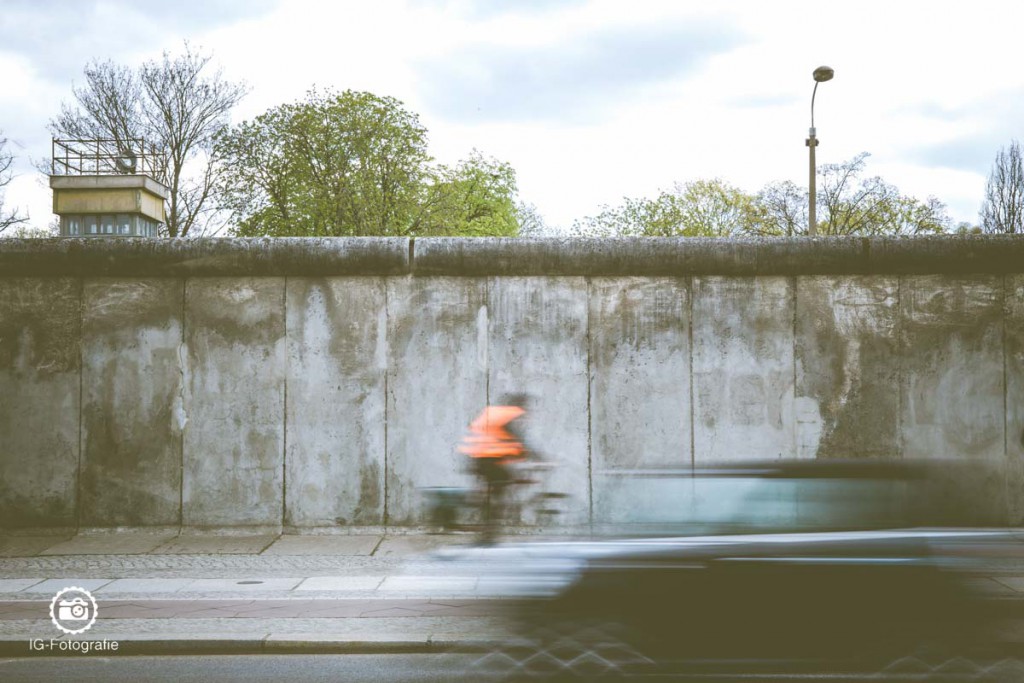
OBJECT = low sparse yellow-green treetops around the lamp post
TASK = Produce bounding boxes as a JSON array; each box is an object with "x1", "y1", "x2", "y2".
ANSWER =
[{"x1": 573, "y1": 154, "x2": 951, "y2": 237}]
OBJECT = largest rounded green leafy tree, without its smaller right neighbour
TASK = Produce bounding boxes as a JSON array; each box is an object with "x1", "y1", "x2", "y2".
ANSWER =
[{"x1": 216, "y1": 90, "x2": 429, "y2": 236}]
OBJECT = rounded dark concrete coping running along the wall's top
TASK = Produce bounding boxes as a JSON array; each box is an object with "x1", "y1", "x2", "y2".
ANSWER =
[{"x1": 0, "y1": 234, "x2": 1024, "y2": 278}]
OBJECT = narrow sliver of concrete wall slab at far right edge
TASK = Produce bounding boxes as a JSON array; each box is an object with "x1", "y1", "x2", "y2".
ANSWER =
[{"x1": 1004, "y1": 275, "x2": 1024, "y2": 525}]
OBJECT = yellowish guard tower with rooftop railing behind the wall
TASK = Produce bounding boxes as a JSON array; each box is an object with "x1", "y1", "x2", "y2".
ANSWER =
[{"x1": 50, "y1": 139, "x2": 167, "y2": 238}]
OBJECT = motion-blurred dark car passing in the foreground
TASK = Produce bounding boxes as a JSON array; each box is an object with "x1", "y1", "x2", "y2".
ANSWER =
[{"x1": 464, "y1": 461, "x2": 1024, "y2": 681}]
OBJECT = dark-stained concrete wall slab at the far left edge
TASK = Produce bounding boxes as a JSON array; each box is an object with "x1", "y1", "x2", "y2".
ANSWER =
[{"x1": 0, "y1": 278, "x2": 81, "y2": 528}]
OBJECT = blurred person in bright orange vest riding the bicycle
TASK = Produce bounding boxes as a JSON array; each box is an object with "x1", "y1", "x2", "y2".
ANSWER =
[{"x1": 459, "y1": 393, "x2": 530, "y2": 543}]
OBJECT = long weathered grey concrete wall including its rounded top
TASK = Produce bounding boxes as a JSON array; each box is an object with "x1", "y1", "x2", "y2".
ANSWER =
[{"x1": 0, "y1": 237, "x2": 1024, "y2": 529}]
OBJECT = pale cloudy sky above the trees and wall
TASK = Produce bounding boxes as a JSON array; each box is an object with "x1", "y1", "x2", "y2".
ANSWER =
[{"x1": 0, "y1": 0, "x2": 1024, "y2": 230}]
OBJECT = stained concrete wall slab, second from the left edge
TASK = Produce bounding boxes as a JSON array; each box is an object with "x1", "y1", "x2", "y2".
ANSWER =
[{"x1": 81, "y1": 279, "x2": 184, "y2": 526}]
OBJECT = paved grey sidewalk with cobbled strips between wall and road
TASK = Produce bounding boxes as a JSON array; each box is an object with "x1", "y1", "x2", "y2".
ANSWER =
[{"x1": 0, "y1": 531, "x2": 528, "y2": 656}]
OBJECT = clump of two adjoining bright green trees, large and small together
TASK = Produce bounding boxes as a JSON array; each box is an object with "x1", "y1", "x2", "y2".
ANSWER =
[{"x1": 215, "y1": 90, "x2": 519, "y2": 237}]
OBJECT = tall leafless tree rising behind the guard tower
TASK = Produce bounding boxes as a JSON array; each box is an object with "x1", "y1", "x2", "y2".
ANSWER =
[{"x1": 50, "y1": 43, "x2": 248, "y2": 238}]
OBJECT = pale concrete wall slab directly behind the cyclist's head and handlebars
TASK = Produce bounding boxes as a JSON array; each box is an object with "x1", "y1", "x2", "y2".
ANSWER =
[{"x1": 487, "y1": 278, "x2": 591, "y2": 525}]
